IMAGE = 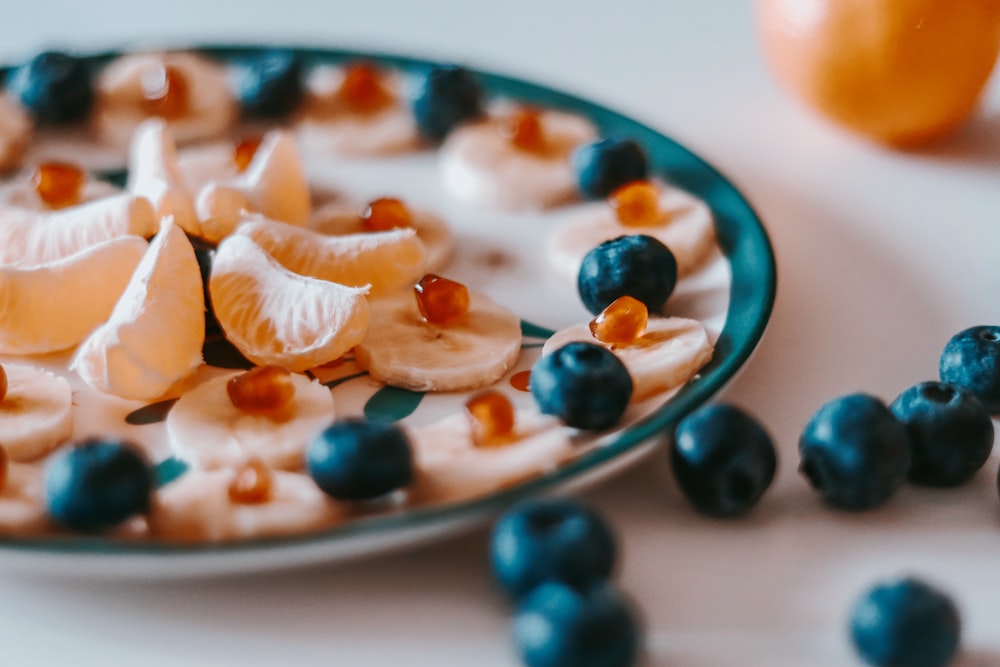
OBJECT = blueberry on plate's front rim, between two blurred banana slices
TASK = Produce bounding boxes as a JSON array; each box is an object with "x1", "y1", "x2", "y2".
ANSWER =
[{"x1": 306, "y1": 418, "x2": 413, "y2": 500}]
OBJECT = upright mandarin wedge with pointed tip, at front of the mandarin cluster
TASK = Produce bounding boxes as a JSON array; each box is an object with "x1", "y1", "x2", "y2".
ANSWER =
[{"x1": 72, "y1": 218, "x2": 205, "y2": 400}]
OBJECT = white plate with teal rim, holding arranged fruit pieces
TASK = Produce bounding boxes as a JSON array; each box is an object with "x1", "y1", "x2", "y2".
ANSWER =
[{"x1": 0, "y1": 46, "x2": 775, "y2": 576}]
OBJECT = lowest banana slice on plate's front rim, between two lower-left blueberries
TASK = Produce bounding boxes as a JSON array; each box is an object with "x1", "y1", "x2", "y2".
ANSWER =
[{"x1": 149, "y1": 469, "x2": 342, "y2": 542}]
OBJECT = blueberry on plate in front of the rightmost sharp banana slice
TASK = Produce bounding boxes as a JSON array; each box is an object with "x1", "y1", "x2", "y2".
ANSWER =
[{"x1": 531, "y1": 342, "x2": 632, "y2": 429}]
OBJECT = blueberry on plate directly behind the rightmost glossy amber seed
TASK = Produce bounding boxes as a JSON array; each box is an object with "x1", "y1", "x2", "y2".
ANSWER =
[{"x1": 576, "y1": 234, "x2": 677, "y2": 315}]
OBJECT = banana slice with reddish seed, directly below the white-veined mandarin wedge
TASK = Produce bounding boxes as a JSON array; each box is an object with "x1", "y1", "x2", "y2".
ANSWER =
[{"x1": 167, "y1": 373, "x2": 334, "y2": 470}]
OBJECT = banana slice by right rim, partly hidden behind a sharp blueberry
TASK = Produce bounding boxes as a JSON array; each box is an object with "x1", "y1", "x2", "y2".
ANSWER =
[{"x1": 542, "y1": 317, "x2": 713, "y2": 402}]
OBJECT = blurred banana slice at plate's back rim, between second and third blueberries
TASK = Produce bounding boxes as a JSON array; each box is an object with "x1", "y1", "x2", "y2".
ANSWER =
[{"x1": 295, "y1": 66, "x2": 420, "y2": 156}]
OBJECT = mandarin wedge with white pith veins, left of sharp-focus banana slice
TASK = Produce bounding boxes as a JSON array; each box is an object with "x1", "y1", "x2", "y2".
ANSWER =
[{"x1": 209, "y1": 234, "x2": 368, "y2": 371}]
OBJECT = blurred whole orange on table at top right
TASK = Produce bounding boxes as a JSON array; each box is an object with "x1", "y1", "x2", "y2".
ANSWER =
[{"x1": 755, "y1": 0, "x2": 1000, "y2": 146}]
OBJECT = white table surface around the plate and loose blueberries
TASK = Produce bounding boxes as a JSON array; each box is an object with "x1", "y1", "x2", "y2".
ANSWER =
[{"x1": 0, "y1": 0, "x2": 1000, "y2": 667}]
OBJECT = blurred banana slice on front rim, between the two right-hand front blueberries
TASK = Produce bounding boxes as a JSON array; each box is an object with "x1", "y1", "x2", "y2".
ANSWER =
[{"x1": 410, "y1": 410, "x2": 575, "y2": 502}]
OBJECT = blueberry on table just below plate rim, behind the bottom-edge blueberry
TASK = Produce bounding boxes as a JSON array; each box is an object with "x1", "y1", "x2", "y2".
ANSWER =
[{"x1": 490, "y1": 498, "x2": 615, "y2": 598}]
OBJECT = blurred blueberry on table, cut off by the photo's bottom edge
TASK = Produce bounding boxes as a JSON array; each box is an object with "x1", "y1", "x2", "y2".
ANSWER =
[{"x1": 512, "y1": 581, "x2": 639, "y2": 667}]
